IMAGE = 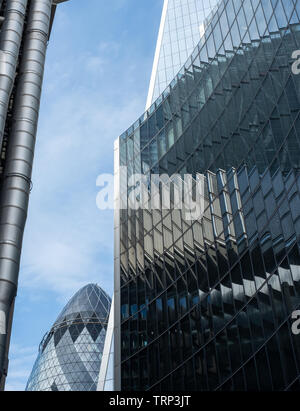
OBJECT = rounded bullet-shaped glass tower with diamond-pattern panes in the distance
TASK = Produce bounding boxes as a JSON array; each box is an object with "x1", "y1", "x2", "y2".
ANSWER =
[{"x1": 26, "y1": 284, "x2": 111, "y2": 391}]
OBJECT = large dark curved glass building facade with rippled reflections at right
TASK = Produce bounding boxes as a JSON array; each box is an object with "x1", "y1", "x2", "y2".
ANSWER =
[{"x1": 115, "y1": 0, "x2": 300, "y2": 391}]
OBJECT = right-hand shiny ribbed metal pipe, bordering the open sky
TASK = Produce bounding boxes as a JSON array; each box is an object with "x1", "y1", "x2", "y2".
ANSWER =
[{"x1": 0, "y1": 0, "x2": 52, "y2": 390}]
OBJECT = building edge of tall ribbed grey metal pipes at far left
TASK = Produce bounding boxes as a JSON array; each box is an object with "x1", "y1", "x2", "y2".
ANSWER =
[{"x1": 0, "y1": 0, "x2": 66, "y2": 389}]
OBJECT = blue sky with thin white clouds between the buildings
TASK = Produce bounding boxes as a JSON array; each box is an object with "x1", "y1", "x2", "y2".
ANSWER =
[{"x1": 6, "y1": 0, "x2": 163, "y2": 390}]
